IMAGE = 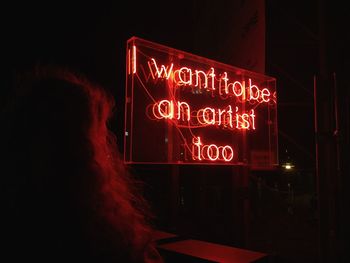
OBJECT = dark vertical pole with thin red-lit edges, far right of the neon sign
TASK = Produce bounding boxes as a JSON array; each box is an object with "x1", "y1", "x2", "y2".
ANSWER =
[{"x1": 315, "y1": 0, "x2": 335, "y2": 263}]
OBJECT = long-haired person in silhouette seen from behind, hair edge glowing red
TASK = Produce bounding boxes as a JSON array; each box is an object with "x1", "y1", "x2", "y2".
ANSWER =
[{"x1": 2, "y1": 65, "x2": 160, "y2": 262}]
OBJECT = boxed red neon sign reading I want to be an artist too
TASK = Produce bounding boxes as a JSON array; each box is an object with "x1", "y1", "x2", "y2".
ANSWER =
[{"x1": 124, "y1": 37, "x2": 278, "y2": 168}]
